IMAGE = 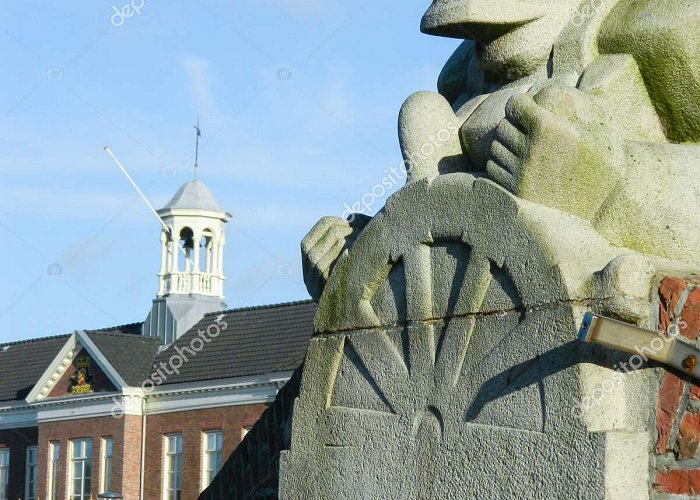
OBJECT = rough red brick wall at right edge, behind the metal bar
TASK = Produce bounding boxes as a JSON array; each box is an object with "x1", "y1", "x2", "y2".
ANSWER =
[{"x1": 654, "y1": 278, "x2": 700, "y2": 495}]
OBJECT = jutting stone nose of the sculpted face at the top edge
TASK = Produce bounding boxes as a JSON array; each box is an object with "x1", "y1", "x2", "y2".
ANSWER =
[{"x1": 421, "y1": 0, "x2": 544, "y2": 43}]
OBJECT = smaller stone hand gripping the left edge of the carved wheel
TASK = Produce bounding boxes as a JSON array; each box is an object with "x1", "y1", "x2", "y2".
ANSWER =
[{"x1": 301, "y1": 214, "x2": 371, "y2": 301}]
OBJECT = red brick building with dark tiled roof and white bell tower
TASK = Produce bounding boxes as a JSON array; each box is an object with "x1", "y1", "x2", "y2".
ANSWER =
[{"x1": 0, "y1": 181, "x2": 315, "y2": 500}]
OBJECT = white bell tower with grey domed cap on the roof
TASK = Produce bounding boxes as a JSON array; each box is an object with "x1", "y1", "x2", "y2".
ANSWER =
[{"x1": 143, "y1": 180, "x2": 231, "y2": 345}]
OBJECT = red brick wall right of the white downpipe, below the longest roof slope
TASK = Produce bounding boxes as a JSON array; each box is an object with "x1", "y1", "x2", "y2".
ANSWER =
[{"x1": 144, "y1": 404, "x2": 268, "y2": 500}]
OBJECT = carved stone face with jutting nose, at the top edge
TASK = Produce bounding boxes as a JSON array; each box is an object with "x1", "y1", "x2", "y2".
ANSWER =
[{"x1": 421, "y1": 0, "x2": 591, "y2": 80}]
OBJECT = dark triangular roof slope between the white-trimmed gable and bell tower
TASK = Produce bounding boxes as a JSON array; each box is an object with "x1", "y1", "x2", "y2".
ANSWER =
[{"x1": 87, "y1": 331, "x2": 160, "y2": 386}]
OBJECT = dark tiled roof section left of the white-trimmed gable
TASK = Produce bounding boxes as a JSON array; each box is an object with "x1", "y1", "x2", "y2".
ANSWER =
[{"x1": 0, "y1": 335, "x2": 70, "y2": 401}]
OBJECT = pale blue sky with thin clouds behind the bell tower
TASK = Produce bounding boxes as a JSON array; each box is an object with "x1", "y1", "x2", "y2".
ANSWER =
[{"x1": 0, "y1": 0, "x2": 458, "y2": 342}]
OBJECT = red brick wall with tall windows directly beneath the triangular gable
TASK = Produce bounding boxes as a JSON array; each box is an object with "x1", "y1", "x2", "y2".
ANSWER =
[{"x1": 39, "y1": 415, "x2": 141, "y2": 498}]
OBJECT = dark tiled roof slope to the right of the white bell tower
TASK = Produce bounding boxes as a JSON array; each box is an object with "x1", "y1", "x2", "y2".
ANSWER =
[{"x1": 156, "y1": 301, "x2": 316, "y2": 385}]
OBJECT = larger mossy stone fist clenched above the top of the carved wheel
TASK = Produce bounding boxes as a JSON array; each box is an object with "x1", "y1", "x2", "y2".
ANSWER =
[{"x1": 487, "y1": 86, "x2": 625, "y2": 219}]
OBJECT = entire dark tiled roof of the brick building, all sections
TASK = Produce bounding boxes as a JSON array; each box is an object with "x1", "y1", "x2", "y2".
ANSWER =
[{"x1": 0, "y1": 301, "x2": 316, "y2": 401}]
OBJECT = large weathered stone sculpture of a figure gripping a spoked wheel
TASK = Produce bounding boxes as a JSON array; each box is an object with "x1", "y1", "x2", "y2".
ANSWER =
[{"x1": 280, "y1": 0, "x2": 700, "y2": 499}]
